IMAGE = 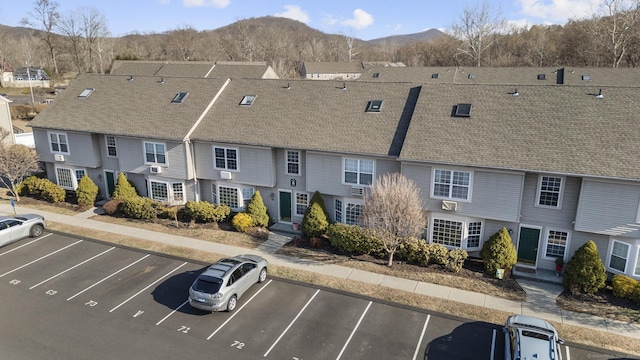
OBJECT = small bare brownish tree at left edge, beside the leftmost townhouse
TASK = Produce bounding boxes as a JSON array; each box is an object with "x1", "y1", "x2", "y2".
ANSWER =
[{"x1": 0, "y1": 144, "x2": 40, "y2": 201}]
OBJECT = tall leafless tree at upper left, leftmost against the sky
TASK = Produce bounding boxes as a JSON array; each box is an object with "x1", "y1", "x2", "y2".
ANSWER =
[{"x1": 20, "y1": 0, "x2": 60, "y2": 74}]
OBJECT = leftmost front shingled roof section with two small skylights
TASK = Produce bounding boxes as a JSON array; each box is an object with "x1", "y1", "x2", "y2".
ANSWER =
[{"x1": 31, "y1": 74, "x2": 230, "y2": 140}]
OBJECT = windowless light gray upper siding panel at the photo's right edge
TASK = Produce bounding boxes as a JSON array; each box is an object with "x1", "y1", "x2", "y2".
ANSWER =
[{"x1": 575, "y1": 180, "x2": 640, "y2": 239}]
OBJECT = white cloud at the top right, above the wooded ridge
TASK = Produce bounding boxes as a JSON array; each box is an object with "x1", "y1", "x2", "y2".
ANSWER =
[{"x1": 517, "y1": 0, "x2": 601, "y2": 24}]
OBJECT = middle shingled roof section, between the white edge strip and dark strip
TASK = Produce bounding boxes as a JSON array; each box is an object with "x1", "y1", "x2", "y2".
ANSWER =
[{"x1": 191, "y1": 79, "x2": 420, "y2": 156}]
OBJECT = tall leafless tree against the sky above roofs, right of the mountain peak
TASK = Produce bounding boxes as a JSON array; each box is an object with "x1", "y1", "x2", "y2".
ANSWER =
[{"x1": 451, "y1": 0, "x2": 505, "y2": 67}]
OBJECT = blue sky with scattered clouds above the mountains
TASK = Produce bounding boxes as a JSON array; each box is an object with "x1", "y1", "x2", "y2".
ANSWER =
[{"x1": 0, "y1": 0, "x2": 602, "y2": 40}]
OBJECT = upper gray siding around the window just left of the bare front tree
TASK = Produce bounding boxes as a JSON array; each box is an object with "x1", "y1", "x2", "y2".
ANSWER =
[{"x1": 304, "y1": 152, "x2": 400, "y2": 196}]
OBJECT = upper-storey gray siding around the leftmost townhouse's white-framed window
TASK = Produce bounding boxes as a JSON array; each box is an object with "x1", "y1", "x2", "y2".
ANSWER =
[{"x1": 33, "y1": 129, "x2": 102, "y2": 168}]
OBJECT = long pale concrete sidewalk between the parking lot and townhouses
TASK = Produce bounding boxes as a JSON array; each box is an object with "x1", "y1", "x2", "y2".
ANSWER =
[{"x1": 0, "y1": 201, "x2": 640, "y2": 339}]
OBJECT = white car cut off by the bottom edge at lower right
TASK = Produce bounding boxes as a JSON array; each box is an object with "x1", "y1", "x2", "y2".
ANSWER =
[{"x1": 504, "y1": 315, "x2": 564, "y2": 360}]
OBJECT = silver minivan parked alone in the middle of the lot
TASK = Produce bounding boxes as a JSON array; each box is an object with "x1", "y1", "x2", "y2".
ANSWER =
[{"x1": 189, "y1": 255, "x2": 267, "y2": 312}]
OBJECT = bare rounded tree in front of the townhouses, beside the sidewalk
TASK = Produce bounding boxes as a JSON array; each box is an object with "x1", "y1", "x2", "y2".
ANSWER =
[{"x1": 361, "y1": 173, "x2": 425, "y2": 266}]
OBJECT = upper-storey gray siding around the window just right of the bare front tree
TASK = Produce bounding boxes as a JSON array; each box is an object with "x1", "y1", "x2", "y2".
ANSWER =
[{"x1": 402, "y1": 163, "x2": 524, "y2": 222}]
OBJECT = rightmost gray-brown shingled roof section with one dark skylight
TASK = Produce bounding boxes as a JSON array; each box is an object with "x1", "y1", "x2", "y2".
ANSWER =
[{"x1": 401, "y1": 84, "x2": 640, "y2": 180}]
